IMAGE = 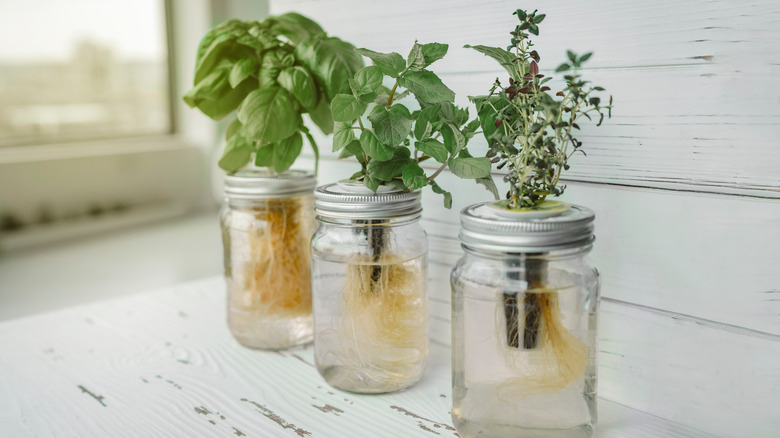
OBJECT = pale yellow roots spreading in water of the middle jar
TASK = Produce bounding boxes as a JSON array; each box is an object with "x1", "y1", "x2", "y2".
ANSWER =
[{"x1": 339, "y1": 255, "x2": 428, "y2": 386}]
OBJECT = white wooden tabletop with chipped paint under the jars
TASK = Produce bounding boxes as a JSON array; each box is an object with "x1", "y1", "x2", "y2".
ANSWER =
[{"x1": 0, "y1": 277, "x2": 710, "y2": 438}]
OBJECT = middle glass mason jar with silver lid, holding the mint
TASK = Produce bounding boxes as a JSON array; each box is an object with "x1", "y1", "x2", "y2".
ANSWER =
[{"x1": 312, "y1": 182, "x2": 428, "y2": 394}]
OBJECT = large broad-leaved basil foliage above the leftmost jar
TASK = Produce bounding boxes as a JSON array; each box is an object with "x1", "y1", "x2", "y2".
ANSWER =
[{"x1": 183, "y1": 12, "x2": 366, "y2": 172}]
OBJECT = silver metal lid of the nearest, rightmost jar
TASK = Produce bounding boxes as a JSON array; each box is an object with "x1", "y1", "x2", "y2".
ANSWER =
[{"x1": 460, "y1": 201, "x2": 595, "y2": 253}]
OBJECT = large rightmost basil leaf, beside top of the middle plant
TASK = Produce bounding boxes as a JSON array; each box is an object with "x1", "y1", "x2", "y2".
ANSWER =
[{"x1": 295, "y1": 34, "x2": 363, "y2": 97}]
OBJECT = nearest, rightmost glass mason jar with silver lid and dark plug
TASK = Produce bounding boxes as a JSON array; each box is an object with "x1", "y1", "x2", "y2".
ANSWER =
[{"x1": 451, "y1": 202, "x2": 599, "y2": 438}]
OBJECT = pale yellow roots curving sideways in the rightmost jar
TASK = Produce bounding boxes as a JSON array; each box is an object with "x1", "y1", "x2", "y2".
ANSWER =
[{"x1": 497, "y1": 292, "x2": 588, "y2": 402}]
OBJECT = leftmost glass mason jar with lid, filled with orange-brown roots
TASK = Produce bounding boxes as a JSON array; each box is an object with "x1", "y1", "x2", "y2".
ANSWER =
[{"x1": 221, "y1": 169, "x2": 317, "y2": 350}]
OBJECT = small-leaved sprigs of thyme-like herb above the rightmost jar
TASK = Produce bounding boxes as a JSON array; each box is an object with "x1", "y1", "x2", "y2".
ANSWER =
[{"x1": 466, "y1": 9, "x2": 612, "y2": 209}]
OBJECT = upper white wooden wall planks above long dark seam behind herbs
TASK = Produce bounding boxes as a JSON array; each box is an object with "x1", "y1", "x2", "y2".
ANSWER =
[{"x1": 271, "y1": 0, "x2": 780, "y2": 199}]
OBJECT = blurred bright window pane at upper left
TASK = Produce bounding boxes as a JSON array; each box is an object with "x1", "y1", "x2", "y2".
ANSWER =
[{"x1": 0, "y1": 0, "x2": 172, "y2": 146}]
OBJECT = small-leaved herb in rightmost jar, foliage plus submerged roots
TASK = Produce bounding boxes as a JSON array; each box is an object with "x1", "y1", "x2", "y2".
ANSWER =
[{"x1": 466, "y1": 10, "x2": 612, "y2": 394}]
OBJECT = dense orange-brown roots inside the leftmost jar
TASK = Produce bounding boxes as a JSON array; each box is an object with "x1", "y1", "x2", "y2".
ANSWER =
[{"x1": 231, "y1": 198, "x2": 313, "y2": 319}]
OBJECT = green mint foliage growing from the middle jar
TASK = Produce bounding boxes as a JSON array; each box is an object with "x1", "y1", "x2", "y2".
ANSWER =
[{"x1": 331, "y1": 42, "x2": 495, "y2": 208}]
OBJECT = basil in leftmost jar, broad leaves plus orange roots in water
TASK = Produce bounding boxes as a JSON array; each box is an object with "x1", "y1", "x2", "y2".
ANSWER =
[{"x1": 183, "y1": 13, "x2": 364, "y2": 348}]
